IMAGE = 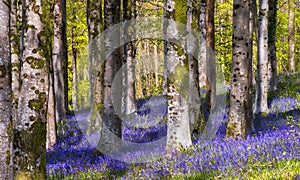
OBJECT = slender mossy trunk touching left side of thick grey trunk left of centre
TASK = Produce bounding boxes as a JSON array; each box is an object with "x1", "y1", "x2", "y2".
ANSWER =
[{"x1": 87, "y1": 0, "x2": 103, "y2": 131}]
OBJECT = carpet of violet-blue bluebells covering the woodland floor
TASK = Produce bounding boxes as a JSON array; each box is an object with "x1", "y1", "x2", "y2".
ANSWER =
[{"x1": 47, "y1": 74, "x2": 300, "y2": 179}]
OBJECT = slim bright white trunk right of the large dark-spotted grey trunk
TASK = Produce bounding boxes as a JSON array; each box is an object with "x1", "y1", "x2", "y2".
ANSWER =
[{"x1": 255, "y1": 0, "x2": 268, "y2": 114}]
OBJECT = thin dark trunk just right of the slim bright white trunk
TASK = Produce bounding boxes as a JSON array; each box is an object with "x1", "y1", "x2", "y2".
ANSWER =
[{"x1": 268, "y1": 0, "x2": 278, "y2": 91}]
